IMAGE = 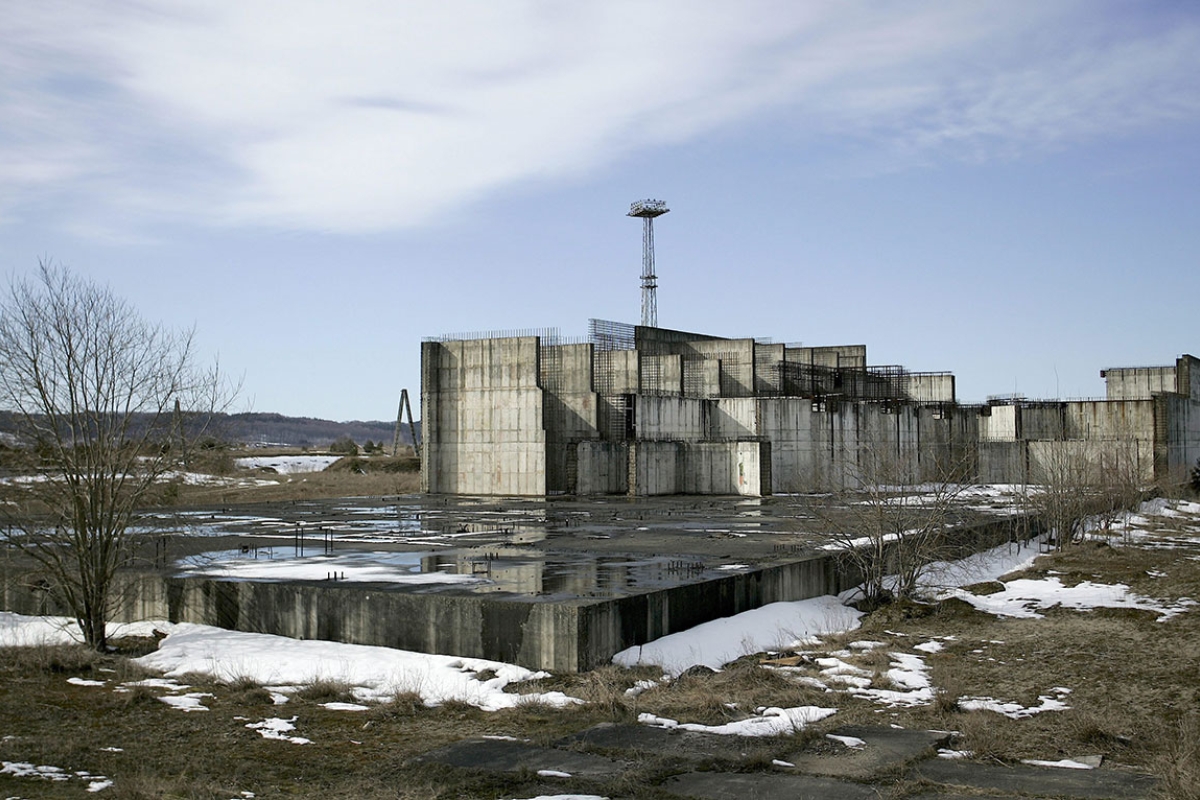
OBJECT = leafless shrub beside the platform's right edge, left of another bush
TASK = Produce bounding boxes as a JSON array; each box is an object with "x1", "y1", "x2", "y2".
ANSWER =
[{"x1": 810, "y1": 451, "x2": 973, "y2": 608}]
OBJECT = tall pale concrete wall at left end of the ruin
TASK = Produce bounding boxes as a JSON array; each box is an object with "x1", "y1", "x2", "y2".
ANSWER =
[{"x1": 421, "y1": 336, "x2": 546, "y2": 495}]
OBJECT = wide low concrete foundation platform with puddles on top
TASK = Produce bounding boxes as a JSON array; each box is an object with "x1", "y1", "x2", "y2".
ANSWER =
[{"x1": 0, "y1": 495, "x2": 1019, "y2": 673}]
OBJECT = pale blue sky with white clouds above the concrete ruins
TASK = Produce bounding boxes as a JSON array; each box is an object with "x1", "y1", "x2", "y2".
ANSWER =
[{"x1": 0, "y1": 0, "x2": 1200, "y2": 420}]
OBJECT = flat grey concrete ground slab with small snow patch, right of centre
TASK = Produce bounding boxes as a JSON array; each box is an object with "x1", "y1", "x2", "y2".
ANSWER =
[{"x1": 782, "y1": 726, "x2": 952, "y2": 780}]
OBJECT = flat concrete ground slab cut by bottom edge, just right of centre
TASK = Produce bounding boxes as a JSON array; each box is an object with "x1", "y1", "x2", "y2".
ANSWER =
[{"x1": 660, "y1": 772, "x2": 880, "y2": 800}]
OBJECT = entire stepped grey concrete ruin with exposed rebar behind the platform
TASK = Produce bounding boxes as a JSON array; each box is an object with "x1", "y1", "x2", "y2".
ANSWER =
[{"x1": 421, "y1": 320, "x2": 1200, "y2": 495}]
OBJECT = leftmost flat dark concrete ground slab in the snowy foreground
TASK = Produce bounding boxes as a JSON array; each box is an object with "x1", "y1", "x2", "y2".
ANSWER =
[{"x1": 416, "y1": 739, "x2": 628, "y2": 777}]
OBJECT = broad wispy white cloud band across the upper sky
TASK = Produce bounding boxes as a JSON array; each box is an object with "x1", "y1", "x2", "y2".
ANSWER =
[{"x1": 0, "y1": 0, "x2": 1200, "y2": 233}]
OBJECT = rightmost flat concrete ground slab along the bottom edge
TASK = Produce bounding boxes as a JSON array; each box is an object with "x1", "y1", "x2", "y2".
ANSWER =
[{"x1": 911, "y1": 758, "x2": 1154, "y2": 800}]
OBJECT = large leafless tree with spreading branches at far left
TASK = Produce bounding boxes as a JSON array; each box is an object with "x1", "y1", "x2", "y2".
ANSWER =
[{"x1": 0, "y1": 263, "x2": 227, "y2": 649}]
